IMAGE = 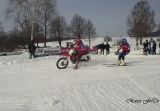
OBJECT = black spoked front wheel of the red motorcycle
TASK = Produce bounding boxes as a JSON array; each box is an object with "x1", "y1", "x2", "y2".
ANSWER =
[{"x1": 56, "y1": 58, "x2": 69, "y2": 69}]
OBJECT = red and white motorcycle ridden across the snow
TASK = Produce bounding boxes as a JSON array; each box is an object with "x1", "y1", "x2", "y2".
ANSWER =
[{"x1": 56, "y1": 49, "x2": 91, "y2": 69}]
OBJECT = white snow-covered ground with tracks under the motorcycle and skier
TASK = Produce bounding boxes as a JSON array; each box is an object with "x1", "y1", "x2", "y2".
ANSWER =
[{"x1": 0, "y1": 39, "x2": 160, "y2": 111}]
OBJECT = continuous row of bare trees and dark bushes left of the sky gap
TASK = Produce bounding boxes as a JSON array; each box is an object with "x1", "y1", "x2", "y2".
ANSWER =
[{"x1": 0, "y1": 0, "x2": 96, "y2": 49}]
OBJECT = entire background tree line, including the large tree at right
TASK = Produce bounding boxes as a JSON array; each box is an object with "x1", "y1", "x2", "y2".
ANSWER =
[{"x1": 0, "y1": 0, "x2": 160, "y2": 51}]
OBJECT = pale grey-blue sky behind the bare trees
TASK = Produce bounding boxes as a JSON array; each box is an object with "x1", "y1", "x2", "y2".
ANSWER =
[{"x1": 0, "y1": 0, "x2": 160, "y2": 36}]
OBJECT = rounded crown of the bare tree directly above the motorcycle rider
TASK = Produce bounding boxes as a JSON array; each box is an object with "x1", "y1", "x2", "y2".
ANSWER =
[{"x1": 71, "y1": 14, "x2": 86, "y2": 38}]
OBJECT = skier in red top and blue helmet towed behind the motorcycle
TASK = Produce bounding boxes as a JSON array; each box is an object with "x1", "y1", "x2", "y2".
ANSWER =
[{"x1": 116, "y1": 38, "x2": 130, "y2": 66}]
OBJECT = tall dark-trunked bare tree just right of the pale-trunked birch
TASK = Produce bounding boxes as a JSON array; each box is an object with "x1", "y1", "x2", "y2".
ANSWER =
[{"x1": 39, "y1": 0, "x2": 56, "y2": 47}]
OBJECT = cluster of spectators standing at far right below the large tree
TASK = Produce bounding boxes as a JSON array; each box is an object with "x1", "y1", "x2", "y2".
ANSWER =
[{"x1": 143, "y1": 38, "x2": 160, "y2": 55}]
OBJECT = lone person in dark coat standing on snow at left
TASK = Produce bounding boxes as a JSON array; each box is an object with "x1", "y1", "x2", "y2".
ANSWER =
[{"x1": 28, "y1": 40, "x2": 36, "y2": 59}]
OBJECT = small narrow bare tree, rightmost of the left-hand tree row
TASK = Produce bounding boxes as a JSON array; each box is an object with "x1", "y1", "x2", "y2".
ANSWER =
[{"x1": 85, "y1": 19, "x2": 96, "y2": 47}]
